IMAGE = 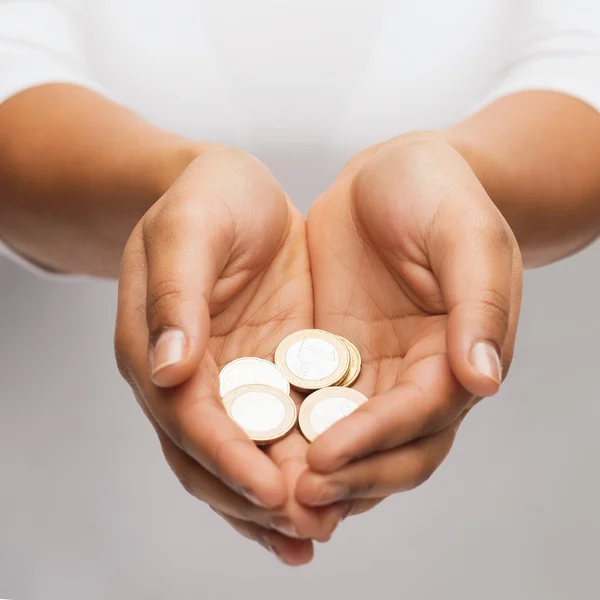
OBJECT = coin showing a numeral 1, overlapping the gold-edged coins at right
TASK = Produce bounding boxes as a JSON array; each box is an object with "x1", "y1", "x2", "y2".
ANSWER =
[{"x1": 275, "y1": 329, "x2": 350, "y2": 391}]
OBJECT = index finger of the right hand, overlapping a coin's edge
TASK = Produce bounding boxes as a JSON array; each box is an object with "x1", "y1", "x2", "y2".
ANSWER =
[{"x1": 307, "y1": 352, "x2": 473, "y2": 473}]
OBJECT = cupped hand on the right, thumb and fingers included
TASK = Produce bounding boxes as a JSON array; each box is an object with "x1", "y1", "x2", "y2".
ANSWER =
[{"x1": 296, "y1": 133, "x2": 522, "y2": 513}]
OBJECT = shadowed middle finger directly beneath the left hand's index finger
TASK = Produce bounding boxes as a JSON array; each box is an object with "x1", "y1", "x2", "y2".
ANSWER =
[{"x1": 158, "y1": 428, "x2": 283, "y2": 529}]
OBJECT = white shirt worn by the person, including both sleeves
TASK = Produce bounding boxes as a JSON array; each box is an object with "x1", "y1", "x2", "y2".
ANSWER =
[{"x1": 0, "y1": 0, "x2": 600, "y2": 274}]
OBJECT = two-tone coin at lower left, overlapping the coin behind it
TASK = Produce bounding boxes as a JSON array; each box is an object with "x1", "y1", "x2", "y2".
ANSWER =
[{"x1": 223, "y1": 385, "x2": 298, "y2": 445}]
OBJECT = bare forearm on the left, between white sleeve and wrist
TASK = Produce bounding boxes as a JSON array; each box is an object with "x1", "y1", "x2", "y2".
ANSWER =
[{"x1": 0, "y1": 85, "x2": 205, "y2": 277}]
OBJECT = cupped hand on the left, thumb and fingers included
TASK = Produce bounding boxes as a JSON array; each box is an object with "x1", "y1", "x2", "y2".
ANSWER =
[{"x1": 115, "y1": 148, "x2": 344, "y2": 564}]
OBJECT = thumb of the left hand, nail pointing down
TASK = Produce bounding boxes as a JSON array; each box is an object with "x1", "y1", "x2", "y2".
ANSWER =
[{"x1": 143, "y1": 169, "x2": 235, "y2": 387}]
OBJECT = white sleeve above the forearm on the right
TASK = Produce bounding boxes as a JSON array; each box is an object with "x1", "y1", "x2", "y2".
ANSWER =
[{"x1": 484, "y1": 0, "x2": 600, "y2": 110}]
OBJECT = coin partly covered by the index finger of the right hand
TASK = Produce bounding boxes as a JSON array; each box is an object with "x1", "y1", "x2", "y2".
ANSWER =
[{"x1": 299, "y1": 387, "x2": 367, "y2": 442}]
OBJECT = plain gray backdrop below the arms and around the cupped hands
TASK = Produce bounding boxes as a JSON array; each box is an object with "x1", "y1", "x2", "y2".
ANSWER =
[{"x1": 0, "y1": 179, "x2": 600, "y2": 600}]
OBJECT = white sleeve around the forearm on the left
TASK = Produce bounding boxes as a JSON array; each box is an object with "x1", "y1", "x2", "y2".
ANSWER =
[{"x1": 0, "y1": 0, "x2": 106, "y2": 279}]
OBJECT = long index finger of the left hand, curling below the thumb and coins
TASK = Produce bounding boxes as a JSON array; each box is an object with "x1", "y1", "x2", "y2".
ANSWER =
[{"x1": 115, "y1": 250, "x2": 287, "y2": 508}]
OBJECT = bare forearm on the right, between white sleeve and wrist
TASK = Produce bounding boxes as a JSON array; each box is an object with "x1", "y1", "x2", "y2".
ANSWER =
[{"x1": 444, "y1": 92, "x2": 600, "y2": 267}]
